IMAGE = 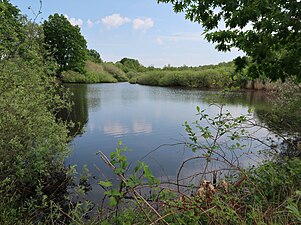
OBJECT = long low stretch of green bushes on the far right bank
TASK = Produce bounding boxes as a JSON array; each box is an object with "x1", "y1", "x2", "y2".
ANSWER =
[{"x1": 127, "y1": 62, "x2": 240, "y2": 88}]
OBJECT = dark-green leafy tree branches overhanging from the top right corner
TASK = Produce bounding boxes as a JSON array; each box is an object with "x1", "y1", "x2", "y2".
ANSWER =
[{"x1": 158, "y1": 0, "x2": 301, "y2": 80}]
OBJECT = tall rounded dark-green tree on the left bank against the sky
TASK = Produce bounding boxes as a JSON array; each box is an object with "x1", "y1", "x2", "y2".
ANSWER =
[{"x1": 43, "y1": 13, "x2": 87, "y2": 74}]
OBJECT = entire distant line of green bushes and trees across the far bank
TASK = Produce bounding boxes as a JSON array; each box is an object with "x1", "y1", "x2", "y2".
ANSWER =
[{"x1": 62, "y1": 55, "x2": 275, "y2": 90}]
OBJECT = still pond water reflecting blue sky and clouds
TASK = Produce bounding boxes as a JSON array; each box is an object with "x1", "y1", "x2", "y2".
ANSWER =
[{"x1": 66, "y1": 83, "x2": 268, "y2": 198}]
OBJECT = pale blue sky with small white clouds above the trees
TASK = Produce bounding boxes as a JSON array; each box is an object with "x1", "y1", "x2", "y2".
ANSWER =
[{"x1": 11, "y1": 0, "x2": 242, "y2": 67}]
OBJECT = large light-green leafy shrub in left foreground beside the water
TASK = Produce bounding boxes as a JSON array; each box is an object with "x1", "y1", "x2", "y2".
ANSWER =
[{"x1": 0, "y1": 58, "x2": 69, "y2": 224}]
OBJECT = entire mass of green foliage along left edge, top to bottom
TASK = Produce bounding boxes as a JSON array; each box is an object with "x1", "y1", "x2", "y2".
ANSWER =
[{"x1": 0, "y1": 1, "x2": 70, "y2": 224}]
